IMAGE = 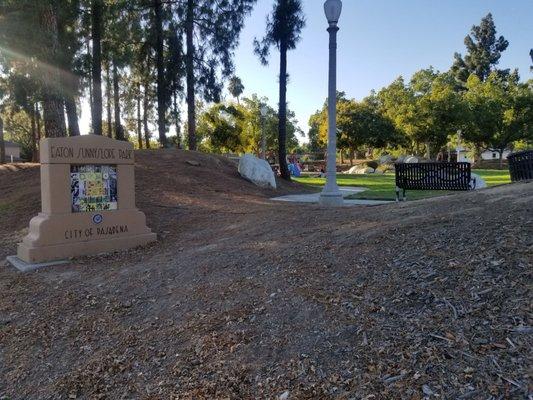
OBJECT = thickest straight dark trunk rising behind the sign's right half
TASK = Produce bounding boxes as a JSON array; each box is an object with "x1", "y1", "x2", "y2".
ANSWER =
[{"x1": 91, "y1": 0, "x2": 103, "y2": 135}]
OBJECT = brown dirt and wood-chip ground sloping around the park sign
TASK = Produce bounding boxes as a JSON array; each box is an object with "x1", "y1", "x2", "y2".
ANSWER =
[{"x1": 0, "y1": 151, "x2": 533, "y2": 399}]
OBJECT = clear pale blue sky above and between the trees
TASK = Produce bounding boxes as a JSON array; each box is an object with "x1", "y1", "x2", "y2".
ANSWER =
[{"x1": 81, "y1": 0, "x2": 533, "y2": 140}]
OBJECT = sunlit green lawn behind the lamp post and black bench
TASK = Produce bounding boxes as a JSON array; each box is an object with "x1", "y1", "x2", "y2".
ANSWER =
[{"x1": 294, "y1": 169, "x2": 511, "y2": 200}]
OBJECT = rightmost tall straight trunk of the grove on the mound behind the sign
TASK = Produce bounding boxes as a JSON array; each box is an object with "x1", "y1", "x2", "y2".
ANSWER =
[{"x1": 185, "y1": 0, "x2": 196, "y2": 150}]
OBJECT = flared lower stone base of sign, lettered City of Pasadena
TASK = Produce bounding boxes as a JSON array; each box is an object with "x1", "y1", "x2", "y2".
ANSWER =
[{"x1": 17, "y1": 209, "x2": 157, "y2": 263}]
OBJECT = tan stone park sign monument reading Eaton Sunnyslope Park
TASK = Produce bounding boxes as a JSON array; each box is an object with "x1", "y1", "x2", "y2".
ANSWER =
[{"x1": 10, "y1": 135, "x2": 157, "y2": 264}]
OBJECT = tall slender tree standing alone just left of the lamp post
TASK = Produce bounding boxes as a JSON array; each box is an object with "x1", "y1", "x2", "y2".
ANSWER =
[{"x1": 254, "y1": 0, "x2": 305, "y2": 180}]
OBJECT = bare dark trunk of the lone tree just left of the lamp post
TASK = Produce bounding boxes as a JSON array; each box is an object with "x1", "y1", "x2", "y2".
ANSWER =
[{"x1": 278, "y1": 41, "x2": 291, "y2": 181}]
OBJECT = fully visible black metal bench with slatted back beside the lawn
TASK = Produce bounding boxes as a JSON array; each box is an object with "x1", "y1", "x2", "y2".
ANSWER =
[{"x1": 395, "y1": 162, "x2": 476, "y2": 201}]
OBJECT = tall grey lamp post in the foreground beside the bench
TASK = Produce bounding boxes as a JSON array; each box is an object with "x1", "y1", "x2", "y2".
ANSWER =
[{"x1": 320, "y1": 0, "x2": 343, "y2": 206}]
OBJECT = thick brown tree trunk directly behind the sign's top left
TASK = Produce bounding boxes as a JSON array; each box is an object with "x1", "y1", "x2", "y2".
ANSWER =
[{"x1": 41, "y1": 3, "x2": 67, "y2": 137}]
